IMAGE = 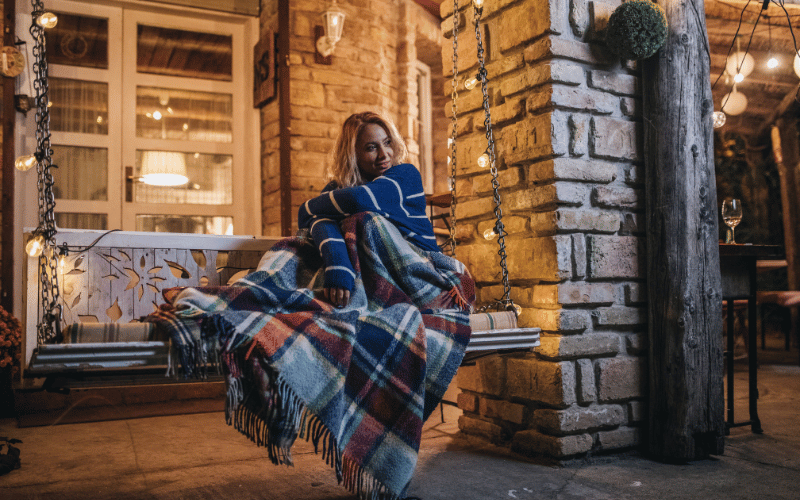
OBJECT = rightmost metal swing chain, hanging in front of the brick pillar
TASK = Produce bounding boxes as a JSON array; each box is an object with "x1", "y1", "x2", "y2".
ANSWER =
[{"x1": 473, "y1": 4, "x2": 516, "y2": 314}]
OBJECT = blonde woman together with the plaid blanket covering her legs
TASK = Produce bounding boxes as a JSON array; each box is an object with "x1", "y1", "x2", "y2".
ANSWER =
[{"x1": 149, "y1": 113, "x2": 475, "y2": 500}]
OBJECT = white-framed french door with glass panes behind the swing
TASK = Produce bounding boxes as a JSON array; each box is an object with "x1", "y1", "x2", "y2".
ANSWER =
[{"x1": 17, "y1": 0, "x2": 261, "y2": 234}]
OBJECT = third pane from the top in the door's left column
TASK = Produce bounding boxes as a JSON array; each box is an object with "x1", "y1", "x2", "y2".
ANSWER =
[{"x1": 52, "y1": 145, "x2": 108, "y2": 200}]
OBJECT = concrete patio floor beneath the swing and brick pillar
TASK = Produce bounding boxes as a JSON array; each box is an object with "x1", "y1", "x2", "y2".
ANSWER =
[{"x1": 0, "y1": 358, "x2": 800, "y2": 500}]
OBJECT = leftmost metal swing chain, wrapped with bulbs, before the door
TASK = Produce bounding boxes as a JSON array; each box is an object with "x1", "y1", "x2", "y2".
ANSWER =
[{"x1": 30, "y1": 0, "x2": 62, "y2": 344}]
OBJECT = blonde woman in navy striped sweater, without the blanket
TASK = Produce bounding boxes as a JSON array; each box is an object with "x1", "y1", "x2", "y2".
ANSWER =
[{"x1": 297, "y1": 111, "x2": 439, "y2": 308}]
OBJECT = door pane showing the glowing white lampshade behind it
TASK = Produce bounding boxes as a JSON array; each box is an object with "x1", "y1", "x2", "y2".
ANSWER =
[{"x1": 134, "y1": 151, "x2": 233, "y2": 205}]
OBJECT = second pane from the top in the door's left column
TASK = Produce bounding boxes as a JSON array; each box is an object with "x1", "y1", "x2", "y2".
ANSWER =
[{"x1": 49, "y1": 78, "x2": 108, "y2": 135}]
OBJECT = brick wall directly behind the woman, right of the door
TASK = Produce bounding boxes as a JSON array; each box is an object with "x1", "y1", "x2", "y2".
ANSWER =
[{"x1": 261, "y1": 0, "x2": 441, "y2": 234}]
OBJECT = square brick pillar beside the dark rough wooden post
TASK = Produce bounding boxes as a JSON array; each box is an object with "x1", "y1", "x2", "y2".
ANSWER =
[{"x1": 441, "y1": 0, "x2": 647, "y2": 458}]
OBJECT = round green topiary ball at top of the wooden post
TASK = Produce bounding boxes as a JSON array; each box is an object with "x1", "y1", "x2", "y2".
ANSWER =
[{"x1": 606, "y1": 0, "x2": 667, "y2": 59}]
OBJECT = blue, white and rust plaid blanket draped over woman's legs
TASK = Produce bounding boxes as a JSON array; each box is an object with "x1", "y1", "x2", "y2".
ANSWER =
[{"x1": 149, "y1": 213, "x2": 475, "y2": 499}]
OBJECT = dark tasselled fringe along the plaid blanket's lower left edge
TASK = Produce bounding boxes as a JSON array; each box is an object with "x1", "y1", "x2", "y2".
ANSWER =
[{"x1": 225, "y1": 375, "x2": 400, "y2": 500}]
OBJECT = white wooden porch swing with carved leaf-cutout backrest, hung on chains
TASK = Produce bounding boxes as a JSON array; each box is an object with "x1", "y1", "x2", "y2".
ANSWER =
[{"x1": 23, "y1": 0, "x2": 541, "y2": 388}]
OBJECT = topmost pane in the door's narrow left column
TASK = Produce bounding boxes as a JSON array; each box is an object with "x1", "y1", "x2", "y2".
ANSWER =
[{"x1": 44, "y1": 12, "x2": 108, "y2": 69}]
